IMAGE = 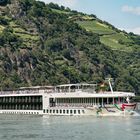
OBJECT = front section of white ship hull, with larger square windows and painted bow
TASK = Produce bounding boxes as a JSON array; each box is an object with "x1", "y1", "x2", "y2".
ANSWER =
[{"x1": 43, "y1": 105, "x2": 136, "y2": 116}]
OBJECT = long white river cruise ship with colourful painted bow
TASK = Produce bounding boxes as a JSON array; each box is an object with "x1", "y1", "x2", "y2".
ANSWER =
[{"x1": 0, "y1": 80, "x2": 136, "y2": 116}]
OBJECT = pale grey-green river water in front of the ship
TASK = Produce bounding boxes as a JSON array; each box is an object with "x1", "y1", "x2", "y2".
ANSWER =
[{"x1": 0, "y1": 115, "x2": 140, "y2": 140}]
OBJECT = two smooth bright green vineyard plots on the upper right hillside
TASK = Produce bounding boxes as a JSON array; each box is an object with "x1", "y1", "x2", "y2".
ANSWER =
[{"x1": 77, "y1": 20, "x2": 133, "y2": 51}]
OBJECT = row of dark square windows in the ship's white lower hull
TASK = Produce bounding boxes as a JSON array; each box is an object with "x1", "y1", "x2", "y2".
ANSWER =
[{"x1": 43, "y1": 109, "x2": 85, "y2": 114}]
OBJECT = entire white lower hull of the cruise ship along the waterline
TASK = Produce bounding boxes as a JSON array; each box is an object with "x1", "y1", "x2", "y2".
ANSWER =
[{"x1": 0, "y1": 107, "x2": 136, "y2": 116}]
